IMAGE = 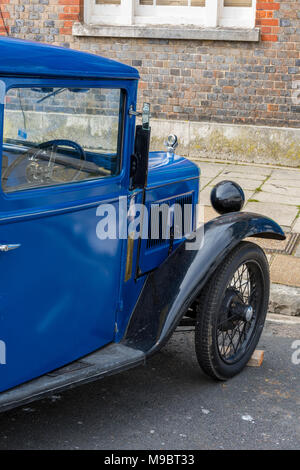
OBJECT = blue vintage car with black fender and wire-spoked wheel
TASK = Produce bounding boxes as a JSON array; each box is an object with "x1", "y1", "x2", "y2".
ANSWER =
[{"x1": 0, "y1": 38, "x2": 285, "y2": 410}]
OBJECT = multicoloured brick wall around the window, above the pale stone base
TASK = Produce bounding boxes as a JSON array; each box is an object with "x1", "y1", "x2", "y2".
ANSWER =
[{"x1": 0, "y1": 0, "x2": 300, "y2": 128}]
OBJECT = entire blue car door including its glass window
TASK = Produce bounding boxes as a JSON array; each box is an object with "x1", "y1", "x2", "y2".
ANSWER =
[{"x1": 0, "y1": 80, "x2": 127, "y2": 391}]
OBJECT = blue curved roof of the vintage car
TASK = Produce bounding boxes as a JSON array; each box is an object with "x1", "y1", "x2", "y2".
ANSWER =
[{"x1": 0, "y1": 37, "x2": 139, "y2": 79}]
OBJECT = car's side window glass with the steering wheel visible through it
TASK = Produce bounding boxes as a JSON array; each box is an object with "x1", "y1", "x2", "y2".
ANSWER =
[{"x1": 2, "y1": 87, "x2": 123, "y2": 192}]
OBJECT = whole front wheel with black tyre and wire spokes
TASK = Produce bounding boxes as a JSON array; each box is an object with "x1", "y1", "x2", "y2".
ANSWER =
[{"x1": 195, "y1": 242, "x2": 270, "y2": 380}]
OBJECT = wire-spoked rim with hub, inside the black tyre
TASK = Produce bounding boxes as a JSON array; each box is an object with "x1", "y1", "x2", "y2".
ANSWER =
[{"x1": 216, "y1": 260, "x2": 263, "y2": 364}]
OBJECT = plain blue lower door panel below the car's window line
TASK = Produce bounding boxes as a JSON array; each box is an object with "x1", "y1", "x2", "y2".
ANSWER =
[{"x1": 0, "y1": 199, "x2": 122, "y2": 391}]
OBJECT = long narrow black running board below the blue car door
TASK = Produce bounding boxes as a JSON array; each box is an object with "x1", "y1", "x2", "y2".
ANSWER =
[{"x1": 0, "y1": 343, "x2": 145, "y2": 411}]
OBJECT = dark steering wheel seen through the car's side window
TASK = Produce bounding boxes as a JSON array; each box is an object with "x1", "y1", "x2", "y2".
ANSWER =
[{"x1": 2, "y1": 139, "x2": 86, "y2": 189}]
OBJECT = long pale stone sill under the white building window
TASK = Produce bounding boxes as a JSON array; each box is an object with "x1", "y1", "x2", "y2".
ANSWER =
[{"x1": 72, "y1": 23, "x2": 260, "y2": 42}]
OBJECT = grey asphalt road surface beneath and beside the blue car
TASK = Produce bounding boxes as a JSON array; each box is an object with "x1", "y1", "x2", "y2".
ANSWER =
[{"x1": 0, "y1": 322, "x2": 300, "y2": 450}]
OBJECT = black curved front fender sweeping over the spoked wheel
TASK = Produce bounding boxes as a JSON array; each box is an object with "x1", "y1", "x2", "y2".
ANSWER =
[{"x1": 122, "y1": 212, "x2": 286, "y2": 355}]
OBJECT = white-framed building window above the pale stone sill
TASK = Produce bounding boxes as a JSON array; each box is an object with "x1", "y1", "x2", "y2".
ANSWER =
[{"x1": 85, "y1": 0, "x2": 256, "y2": 28}]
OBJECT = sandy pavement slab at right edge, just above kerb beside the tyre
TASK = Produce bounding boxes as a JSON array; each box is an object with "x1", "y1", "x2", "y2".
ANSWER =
[{"x1": 270, "y1": 255, "x2": 300, "y2": 287}]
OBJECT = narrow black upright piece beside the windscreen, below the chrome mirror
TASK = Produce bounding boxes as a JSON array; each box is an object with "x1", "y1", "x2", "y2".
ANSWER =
[{"x1": 130, "y1": 126, "x2": 151, "y2": 190}]
